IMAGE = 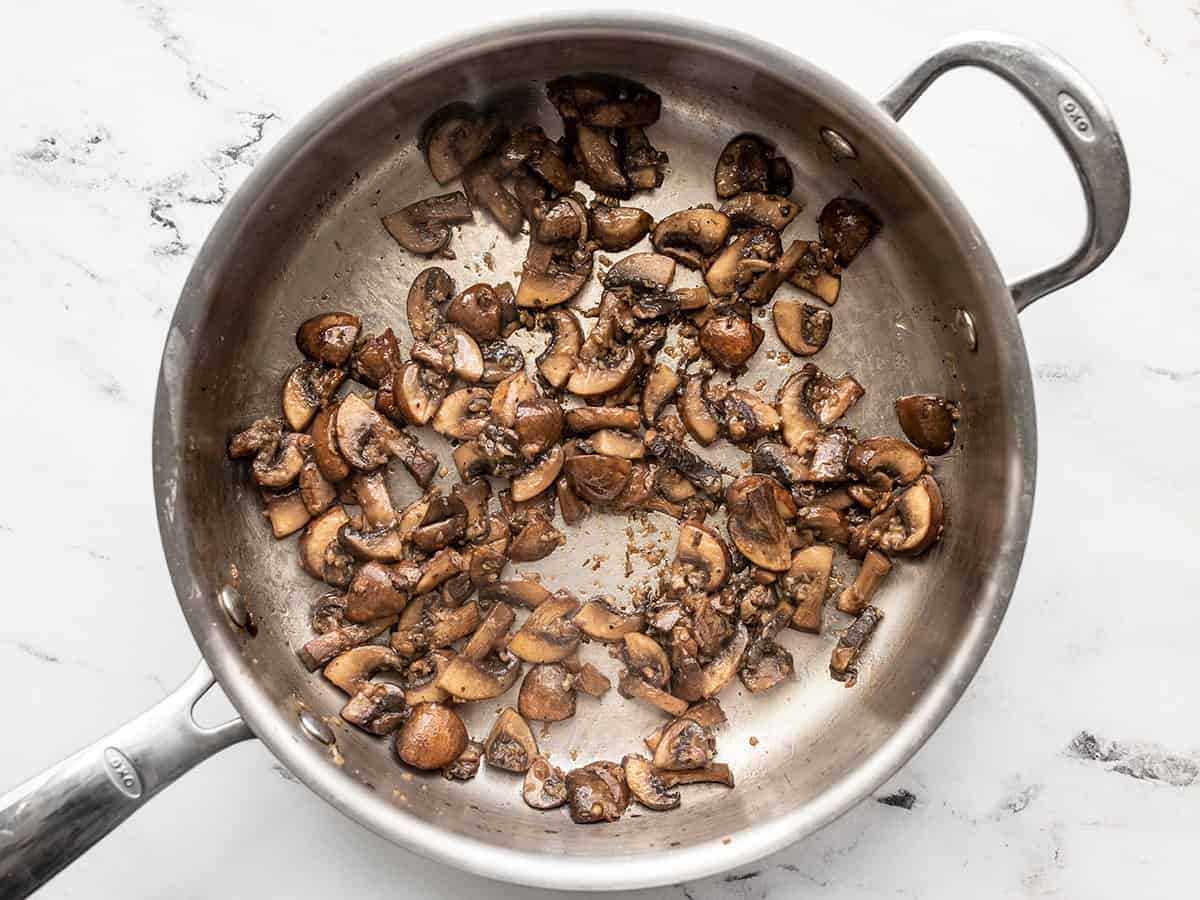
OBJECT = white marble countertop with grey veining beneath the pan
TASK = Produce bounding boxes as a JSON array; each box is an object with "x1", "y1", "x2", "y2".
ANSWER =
[{"x1": 0, "y1": 0, "x2": 1200, "y2": 900}]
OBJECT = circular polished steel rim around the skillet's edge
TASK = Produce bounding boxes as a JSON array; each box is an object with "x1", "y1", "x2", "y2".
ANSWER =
[{"x1": 154, "y1": 11, "x2": 1037, "y2": 890}]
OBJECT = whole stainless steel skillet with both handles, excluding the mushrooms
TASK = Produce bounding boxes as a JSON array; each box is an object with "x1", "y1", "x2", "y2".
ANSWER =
[{"x1": 0, "y1": 14, "x2": 1129, "y2": 896}]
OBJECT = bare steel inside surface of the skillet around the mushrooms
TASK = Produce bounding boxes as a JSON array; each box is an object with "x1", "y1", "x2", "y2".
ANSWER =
[{"x1": 160, "y1": 22, "x2": 1032, "y2": 880}]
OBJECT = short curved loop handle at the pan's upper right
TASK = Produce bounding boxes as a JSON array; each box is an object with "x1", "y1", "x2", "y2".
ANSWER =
[{"x1": 880, "y1": 31, "x2": 1129, "y2": 311}]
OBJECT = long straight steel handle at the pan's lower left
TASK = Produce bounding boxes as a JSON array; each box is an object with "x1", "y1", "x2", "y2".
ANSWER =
[{"x1": 0, "y1": 662, "x2": 253, "y2": 898}]
